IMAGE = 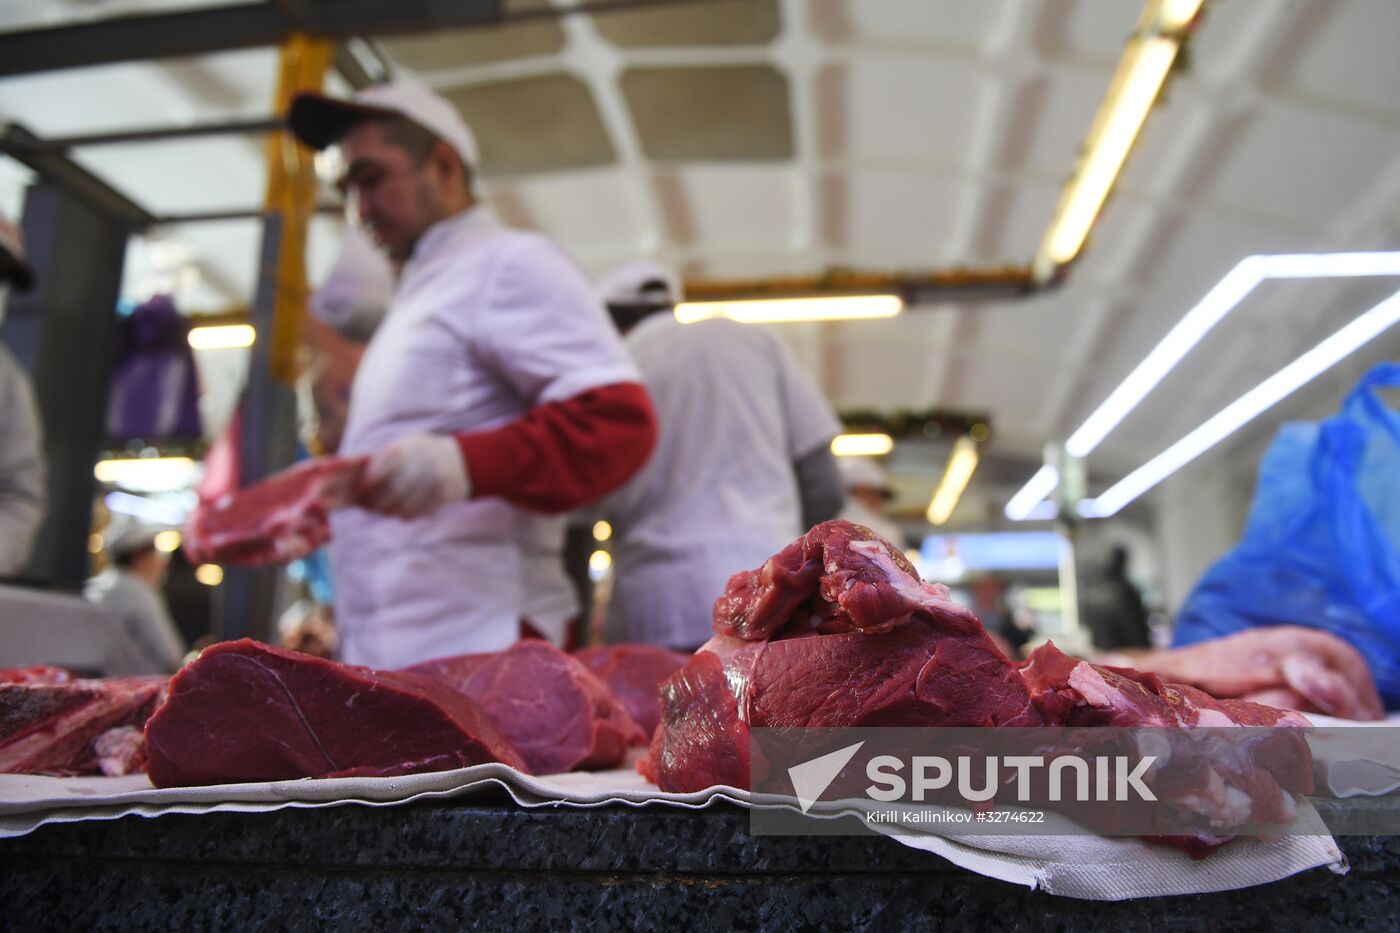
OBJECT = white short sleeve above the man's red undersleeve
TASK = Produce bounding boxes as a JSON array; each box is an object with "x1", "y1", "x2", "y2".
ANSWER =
[{"x1": 479, "y1": 235, "x2": 641, "y2": 405}]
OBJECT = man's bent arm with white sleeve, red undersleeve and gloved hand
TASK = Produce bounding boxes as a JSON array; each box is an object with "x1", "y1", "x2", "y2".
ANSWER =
[{"x1": 360, "y1": 237, "x2": 657, "y2": 517}]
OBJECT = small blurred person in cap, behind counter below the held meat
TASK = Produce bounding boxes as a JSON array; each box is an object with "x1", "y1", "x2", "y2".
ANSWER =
[{"x1": 83, "y1": 527, "x2": 186, "y2": 674}]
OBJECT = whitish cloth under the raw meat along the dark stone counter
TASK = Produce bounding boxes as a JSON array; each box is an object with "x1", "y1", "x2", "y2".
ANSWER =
[{"x1": 0, "y1": 763, "x2": 1345, "y2": 901}]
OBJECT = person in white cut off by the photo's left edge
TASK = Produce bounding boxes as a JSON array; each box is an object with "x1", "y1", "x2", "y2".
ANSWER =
[{"x1": 0, "y1": 214, "x2": 46, "y2": 577}]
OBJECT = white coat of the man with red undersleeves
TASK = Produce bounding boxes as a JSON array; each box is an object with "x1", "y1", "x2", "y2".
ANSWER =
[{"x1": 330, "y1": 206, "x2": 638, "y2": 668}]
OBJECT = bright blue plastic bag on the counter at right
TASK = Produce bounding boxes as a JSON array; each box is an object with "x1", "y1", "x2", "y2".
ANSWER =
[{"x1": 1173, "y1": 363, "x2": 1400, "y2": 709}]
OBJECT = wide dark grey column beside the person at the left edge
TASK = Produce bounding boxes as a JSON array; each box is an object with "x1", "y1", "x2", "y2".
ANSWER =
[{"x1": 4, "y1": 181, "x2": 130, "y2": 590}]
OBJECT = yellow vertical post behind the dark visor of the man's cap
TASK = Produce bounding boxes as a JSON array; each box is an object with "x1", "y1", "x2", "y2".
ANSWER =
[{"x1": 263, "y1": 34, "x2": 332, "y2": 385}]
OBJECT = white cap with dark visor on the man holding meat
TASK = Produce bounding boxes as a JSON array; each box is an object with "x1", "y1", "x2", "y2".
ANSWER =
[{"x1": 287, "y1": 80, "x2": 480, "y2": 172}]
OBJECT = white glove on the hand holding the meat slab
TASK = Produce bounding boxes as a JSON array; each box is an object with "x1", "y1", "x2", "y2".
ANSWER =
[{"x1": 358, "y1": 433, "x2": 472, "y2": 518}]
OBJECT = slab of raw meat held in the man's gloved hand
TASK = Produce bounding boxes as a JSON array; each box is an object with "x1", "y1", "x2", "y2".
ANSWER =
[{"x1": 183, "y1": 457, "x2": 368, "y2": 565}]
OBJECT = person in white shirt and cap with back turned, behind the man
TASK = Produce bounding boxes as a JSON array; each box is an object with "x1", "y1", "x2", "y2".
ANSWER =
[{"x1": 598, "y1": 254, "x2": 843, "y2": 650}]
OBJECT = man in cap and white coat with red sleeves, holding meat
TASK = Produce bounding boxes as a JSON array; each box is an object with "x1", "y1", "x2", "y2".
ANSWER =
[{"x1": 288, "y1": 81, "x2": 657, "y2": 668}]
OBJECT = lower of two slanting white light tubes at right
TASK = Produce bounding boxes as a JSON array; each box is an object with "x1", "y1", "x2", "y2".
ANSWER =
[{"x1": 1079, "y1": 291, "x2": 1400, "y2": 518}]
